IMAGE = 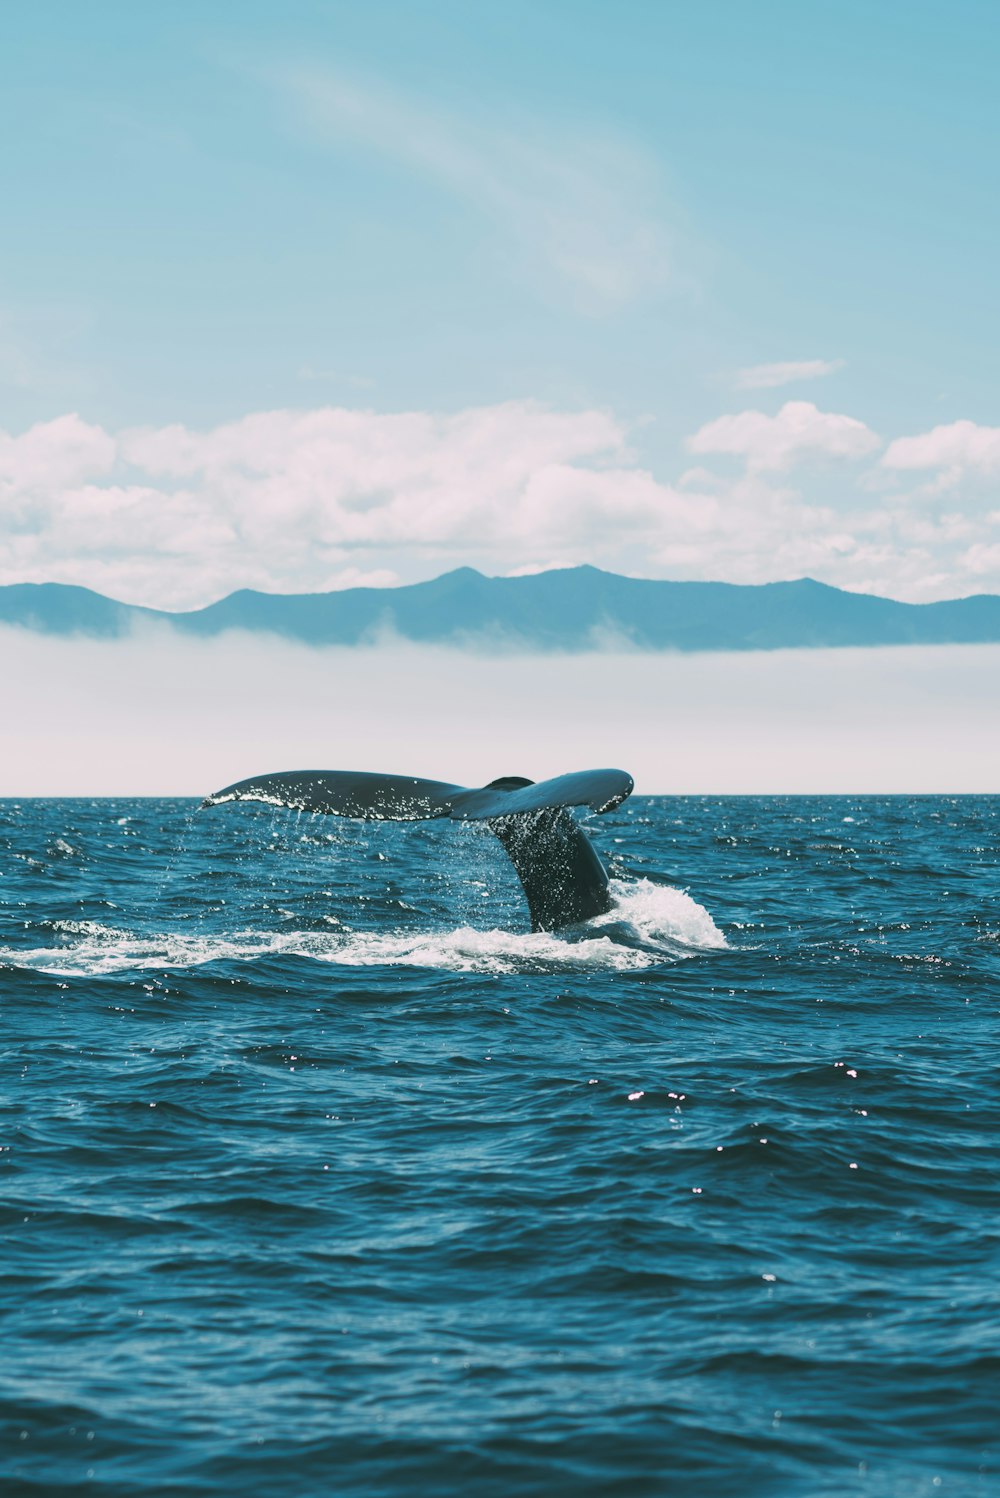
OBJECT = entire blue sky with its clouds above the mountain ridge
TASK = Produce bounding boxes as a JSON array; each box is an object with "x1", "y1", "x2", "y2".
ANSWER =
[{"x1": 0, "y1": 0, "x2": 1000, "y2": 607}]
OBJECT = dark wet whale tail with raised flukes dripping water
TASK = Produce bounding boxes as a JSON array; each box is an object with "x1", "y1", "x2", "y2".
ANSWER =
[{"x1": 202, "y1": 770, "x2": 633, "y2": 932}]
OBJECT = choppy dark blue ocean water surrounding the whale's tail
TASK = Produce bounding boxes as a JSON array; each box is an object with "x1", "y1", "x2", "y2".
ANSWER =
[{"x1": 0, "y1": 797, "x2": 1000, "y2": 1498}]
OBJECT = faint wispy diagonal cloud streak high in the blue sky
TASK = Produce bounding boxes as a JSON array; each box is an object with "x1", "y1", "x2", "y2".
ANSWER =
[{"x1": 266, "y1": 66, "x2": 669, "y2": 310}]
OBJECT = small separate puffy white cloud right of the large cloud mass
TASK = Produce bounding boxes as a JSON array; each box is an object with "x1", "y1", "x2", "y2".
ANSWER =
[{"x1": 687, "y1": 400, "x2": 879, "y2": 472}]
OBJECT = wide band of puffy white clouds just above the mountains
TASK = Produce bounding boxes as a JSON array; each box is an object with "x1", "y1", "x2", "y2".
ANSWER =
[{"x1": 0, "y1": 401, "x2": 1000, "y2": 608}]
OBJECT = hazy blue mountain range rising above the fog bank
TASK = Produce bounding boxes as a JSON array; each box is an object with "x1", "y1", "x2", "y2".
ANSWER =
[{"x1": 0, "y1": 566, "x2": 1000, "y2": 652}]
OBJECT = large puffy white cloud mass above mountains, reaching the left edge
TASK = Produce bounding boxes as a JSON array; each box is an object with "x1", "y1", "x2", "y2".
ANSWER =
[{"x1": 0, "y1": 401, "x2": 676, "y2": 607}]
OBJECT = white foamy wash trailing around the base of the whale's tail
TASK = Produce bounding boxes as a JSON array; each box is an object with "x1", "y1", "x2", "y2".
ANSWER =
[{"x1": 0, "y1": 879, "x2": 726, "y2": 977}]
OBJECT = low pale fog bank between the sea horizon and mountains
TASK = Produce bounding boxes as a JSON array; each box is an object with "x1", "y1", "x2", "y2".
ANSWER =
[{"x1": 0, "y1": 629, "x2": 1000, "y2": 797}]
